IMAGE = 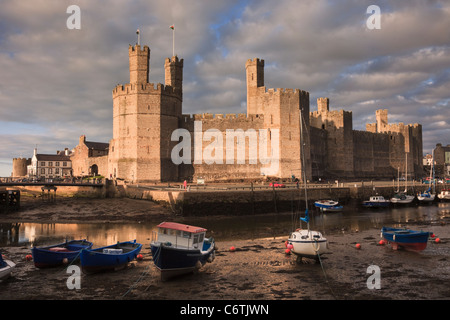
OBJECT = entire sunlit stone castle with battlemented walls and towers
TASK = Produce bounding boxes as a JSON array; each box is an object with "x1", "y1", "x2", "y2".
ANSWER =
[{"x1": 11, "y1": 44, "x2": 422, "y2": 183}]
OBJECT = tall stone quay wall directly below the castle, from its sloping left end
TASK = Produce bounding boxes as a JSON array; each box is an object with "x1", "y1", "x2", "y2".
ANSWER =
[{"x1": 124, "y1": 185, "x2": 440, "y2": 216}]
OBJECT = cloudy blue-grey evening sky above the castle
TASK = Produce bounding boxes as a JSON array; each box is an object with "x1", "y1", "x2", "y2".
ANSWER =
[{"x1": 0, "y1": 0, "x2": 450, "y2": 177}]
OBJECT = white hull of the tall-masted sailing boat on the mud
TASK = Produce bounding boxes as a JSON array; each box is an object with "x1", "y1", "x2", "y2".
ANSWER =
[{"x1": 288, "y1": 230, "x2": 328, "y2": 258}]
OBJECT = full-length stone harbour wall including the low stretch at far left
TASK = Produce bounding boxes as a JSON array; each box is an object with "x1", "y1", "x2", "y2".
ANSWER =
[{"x1": 7, "y1": 181, "x2": 448, "y2": 216}]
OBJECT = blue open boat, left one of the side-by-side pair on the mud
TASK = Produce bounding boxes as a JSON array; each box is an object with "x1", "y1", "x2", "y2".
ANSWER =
[{"x1": 31, "y1": 239, "x2": 92, "y2": 268}]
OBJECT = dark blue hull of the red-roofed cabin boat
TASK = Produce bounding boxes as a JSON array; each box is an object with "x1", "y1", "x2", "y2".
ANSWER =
[{"x1": 150, "y1": 241, "x2": 215, "y2": 280}]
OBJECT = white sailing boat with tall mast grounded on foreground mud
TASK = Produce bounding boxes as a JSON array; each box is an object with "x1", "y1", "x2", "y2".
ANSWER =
[{"x1": 287, "y1": 110, "x2": 328, "y2": 259}]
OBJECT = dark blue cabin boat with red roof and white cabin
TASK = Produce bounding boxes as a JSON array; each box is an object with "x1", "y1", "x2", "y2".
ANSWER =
[{"x1": 150, "y1": 222, "x2": 215, "y2": 281}]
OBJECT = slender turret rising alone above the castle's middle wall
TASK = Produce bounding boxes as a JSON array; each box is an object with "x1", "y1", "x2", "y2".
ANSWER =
[{"x1": 245, "y1": 58, "x2": 265, "y2": 114}]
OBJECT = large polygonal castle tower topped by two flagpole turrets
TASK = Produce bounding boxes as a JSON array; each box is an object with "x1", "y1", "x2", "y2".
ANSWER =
[{"x1": 108, "y1": 45, "x2": 183, "y2": 182}]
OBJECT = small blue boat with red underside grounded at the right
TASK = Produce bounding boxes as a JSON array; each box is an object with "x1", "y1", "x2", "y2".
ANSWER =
[{"x1": 381, "y1": 227, "x2": 430, "y2": 251}]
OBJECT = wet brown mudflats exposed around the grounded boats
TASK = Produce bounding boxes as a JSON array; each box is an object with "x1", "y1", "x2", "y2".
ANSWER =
[{"x1": 0, "y1": 194, "x2": 450, "y2": 301}]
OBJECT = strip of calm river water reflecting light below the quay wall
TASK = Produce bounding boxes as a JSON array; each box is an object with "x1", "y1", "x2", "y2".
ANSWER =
[{"x1": 0, "y1": 203, "x2": 450, "y2": 247}]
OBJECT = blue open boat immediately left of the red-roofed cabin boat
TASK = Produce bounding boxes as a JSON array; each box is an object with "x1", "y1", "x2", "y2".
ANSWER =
[{"x1": 80, "y1": 240, "x2": 142, "y2": 274}]
